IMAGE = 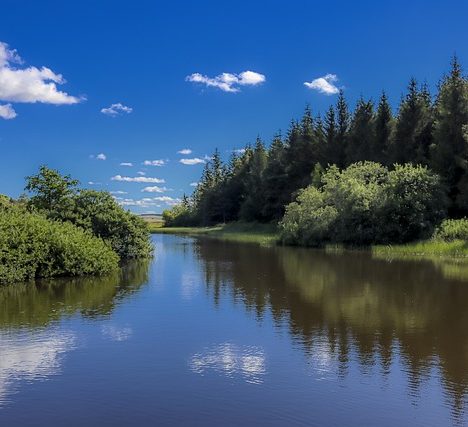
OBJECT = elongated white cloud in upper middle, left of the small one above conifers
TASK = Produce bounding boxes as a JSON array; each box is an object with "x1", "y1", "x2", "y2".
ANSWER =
[{"x1": 185, "y1": 71, "x2": 266, "y2": 92}]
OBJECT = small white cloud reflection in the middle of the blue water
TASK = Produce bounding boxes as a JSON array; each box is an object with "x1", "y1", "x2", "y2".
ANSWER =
[{"x1": 189, "y1": 343, "x2": 266, "y2": 384}]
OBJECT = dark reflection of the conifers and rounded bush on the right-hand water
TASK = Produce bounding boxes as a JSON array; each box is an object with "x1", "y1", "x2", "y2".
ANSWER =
[{"x1": 196, "y1": 240, "x2": 468, "y2": 415}]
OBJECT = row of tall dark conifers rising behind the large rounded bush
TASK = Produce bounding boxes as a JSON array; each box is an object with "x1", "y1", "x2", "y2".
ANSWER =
[{"x1": 164, "y1": 58, "x2": 468, "y2": 232}]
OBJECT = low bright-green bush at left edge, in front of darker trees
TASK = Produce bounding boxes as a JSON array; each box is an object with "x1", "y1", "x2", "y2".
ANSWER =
[{"x1": 0, "y1": 204, "x2": 118, "y2": 283}]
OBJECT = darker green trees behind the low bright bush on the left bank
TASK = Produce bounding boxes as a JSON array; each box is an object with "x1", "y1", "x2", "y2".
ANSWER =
[{"x1": 26, "y1": 166, "x2": 152, "y2": 259}]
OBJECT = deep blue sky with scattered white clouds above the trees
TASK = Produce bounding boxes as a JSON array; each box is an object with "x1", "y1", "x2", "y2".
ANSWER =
[{"x1": 0, "y1": 0, "x2": 468, "y2": 213}]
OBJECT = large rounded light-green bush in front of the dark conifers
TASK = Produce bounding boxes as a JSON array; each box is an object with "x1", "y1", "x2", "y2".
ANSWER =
[{"x1": 280, "y1": 162, "x2": 446, "y2": 246}]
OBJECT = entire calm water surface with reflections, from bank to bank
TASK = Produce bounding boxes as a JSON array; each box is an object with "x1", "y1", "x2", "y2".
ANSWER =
[{"x1": 0, "y1": 236, "x2": 468, "y2": 427}]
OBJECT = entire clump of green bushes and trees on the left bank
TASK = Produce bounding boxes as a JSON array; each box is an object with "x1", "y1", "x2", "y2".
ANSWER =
[{"x1": 0, "y1": 166, "x2": 153, "y2": 284}]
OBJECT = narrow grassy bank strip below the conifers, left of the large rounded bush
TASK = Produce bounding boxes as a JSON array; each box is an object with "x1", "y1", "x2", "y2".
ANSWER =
[{"x1": 151, "y1": 222, "x2": 278, "y2": 246}]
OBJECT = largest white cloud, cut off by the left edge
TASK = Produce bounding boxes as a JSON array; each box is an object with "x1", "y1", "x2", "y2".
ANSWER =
[{"x1": 0, "y1": 42, "x2": 83, "y2": 105}]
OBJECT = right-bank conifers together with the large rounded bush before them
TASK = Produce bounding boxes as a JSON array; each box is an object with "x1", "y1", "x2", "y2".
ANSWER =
[{"x1": 164, "y1": 58, "x2": 468, "y2": 251}]
